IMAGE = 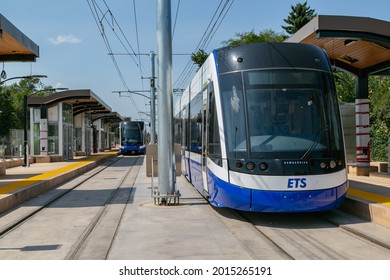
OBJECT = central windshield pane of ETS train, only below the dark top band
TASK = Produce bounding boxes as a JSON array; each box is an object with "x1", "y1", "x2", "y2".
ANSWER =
[{"x1": 246, "y1": 89, "x2": 326, "y2": 151}]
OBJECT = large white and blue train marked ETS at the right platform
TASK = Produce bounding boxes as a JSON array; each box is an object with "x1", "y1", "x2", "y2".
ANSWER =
[{"x1": 174, "y1": 43, "x2": 348, "y2": 212}]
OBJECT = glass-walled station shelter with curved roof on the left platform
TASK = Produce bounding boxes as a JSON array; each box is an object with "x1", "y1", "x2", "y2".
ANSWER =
[{"x1": 27, "y1": 89, "x2": 121, "y2": 162}]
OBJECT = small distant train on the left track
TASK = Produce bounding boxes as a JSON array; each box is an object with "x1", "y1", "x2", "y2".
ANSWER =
[{"x1": 119, "y1": 121, "x2": 145, "y2": 155}]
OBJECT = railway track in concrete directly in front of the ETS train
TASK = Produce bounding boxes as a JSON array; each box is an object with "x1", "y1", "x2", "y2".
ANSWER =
[{"x1": 216, "y1": 209, "x2": 390, "y2": 260}]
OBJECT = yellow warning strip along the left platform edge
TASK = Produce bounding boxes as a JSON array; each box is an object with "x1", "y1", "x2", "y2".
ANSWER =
[{"x1": 0, "y1": 152, "x2": 116, "y2": 194}]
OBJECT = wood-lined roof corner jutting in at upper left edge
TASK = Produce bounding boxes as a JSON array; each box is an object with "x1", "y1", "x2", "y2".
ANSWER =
[{"x1": 0, "y1": 14, "x2": 39, "y2": 61}]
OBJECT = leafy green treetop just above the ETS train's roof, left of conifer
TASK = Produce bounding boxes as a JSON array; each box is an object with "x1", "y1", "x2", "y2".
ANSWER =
[{"x1": 222, "y1": 29, "x2": 287, "y2": 46}]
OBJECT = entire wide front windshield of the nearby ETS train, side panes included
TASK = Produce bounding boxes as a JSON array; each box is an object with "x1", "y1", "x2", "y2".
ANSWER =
[{"x1": 220, "y1": 69, "x2": 343, "y2": 159}]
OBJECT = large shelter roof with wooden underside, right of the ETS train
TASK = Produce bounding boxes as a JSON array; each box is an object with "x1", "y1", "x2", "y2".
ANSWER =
[{"x1": 286, "y1": 15, "x2": 390, "y2": 76}]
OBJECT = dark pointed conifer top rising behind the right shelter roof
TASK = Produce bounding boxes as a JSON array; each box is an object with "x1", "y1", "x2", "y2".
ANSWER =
[{"x1": 282, "y1": 1, "x2": 317, "y2": 35}]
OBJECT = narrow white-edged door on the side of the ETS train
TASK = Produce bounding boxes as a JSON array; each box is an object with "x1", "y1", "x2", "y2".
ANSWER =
[{"x1": 202, "y1": 83, "x2": 213, "y2": 195}]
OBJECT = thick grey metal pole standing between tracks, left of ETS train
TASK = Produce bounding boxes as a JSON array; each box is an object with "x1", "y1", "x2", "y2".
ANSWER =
[{"x1": 157, "y1": 0, "x2": 175, "y2": 195}]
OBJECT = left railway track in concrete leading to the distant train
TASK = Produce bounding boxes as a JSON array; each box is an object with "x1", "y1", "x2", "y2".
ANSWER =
[{"x1": 0, "y1": 156, "x2": 143, "y2": 259}]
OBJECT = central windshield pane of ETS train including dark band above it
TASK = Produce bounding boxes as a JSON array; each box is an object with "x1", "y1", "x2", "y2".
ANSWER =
[{"x1": 244, "y1": 70, "x2": 328, "y2": 154}]
